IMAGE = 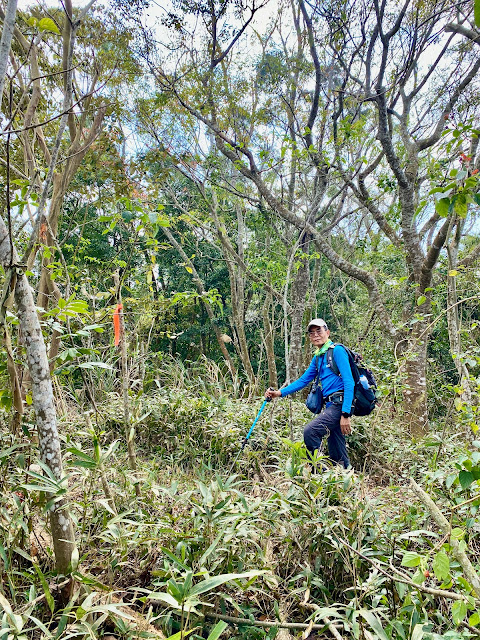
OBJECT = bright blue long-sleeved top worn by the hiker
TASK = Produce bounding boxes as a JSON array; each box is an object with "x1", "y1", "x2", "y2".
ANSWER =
[{"x1": 280, "y1": 344, "x2": 355, "y2": 413}]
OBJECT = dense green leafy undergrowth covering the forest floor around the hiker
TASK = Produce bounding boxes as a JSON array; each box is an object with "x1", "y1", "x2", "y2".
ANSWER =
[{"x1": 0, "y1": 358, "x2": 480, "y2": 640}]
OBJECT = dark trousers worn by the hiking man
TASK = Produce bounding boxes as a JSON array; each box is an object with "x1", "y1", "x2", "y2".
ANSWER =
[{"x1": 303, "y1": 404, "x2": 350, "y2": 469}]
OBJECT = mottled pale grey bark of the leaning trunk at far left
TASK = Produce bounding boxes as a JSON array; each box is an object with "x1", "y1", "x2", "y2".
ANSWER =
[{"x1": 0, "y1": 218, "x2": 75, "y2": 574}]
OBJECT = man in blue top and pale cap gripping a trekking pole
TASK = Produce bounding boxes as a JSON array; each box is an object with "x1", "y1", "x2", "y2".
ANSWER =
[{"x1": 265, "y1": 318, "x2": 355, "y2": 469}]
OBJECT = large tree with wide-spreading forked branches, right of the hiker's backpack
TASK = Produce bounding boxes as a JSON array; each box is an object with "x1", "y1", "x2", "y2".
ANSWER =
[{"x1": 141, "y1": 1, "x2": 480, "y2": 435}]
